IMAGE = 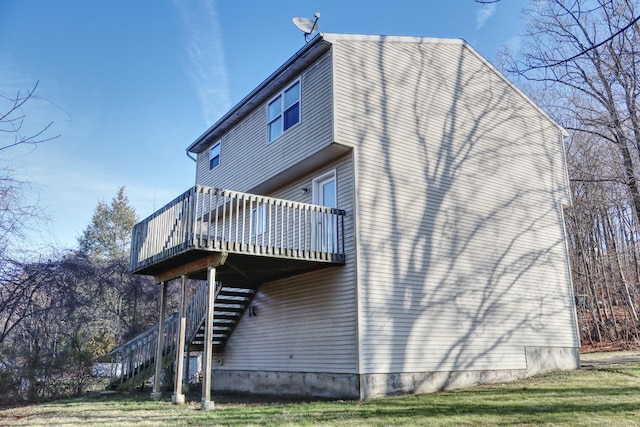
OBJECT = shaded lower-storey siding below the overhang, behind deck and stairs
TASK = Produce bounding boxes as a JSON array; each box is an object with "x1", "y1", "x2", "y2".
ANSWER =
[{"x1": 216, "y1": 153, "x2": 357, "y2": 374}]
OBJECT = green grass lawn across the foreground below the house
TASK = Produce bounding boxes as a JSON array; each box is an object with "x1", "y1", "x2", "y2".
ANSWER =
[{"x1": 0, "y1": 362, "x2": 640, "y2": 426}]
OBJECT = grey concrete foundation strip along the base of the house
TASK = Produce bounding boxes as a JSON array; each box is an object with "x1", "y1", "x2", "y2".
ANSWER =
[{"x1": 213, "y1": 347, "x2": 580, "y2": 399}]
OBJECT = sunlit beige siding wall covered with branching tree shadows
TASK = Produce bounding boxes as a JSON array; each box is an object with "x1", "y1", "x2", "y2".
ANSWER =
[{"x1": 333, "y1": 40, "x2": 578, "y2": 373}]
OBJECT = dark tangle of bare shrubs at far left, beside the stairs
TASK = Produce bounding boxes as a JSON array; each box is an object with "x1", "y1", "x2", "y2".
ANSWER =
[{"x1": 0, "y1": 253, "x2": 108, "y2": 401}]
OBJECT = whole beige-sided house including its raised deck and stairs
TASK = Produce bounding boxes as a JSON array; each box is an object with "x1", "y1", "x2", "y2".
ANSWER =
[{"x1": 109, "y1": 34, "x2": 579, "y2": 407}]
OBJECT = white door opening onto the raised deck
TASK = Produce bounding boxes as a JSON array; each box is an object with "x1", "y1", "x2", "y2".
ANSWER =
[{"x1": 311, "y1": 171, "x2": 338, "y2": 253}]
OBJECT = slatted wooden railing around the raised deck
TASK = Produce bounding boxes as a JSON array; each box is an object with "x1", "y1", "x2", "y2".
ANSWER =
[{"x1": 131, "y1": 185, "x2": 345, "y2": 272}]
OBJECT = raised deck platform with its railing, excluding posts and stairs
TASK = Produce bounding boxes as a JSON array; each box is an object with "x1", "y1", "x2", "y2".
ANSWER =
[{"x1": 130, "y1": 186, "x2": 345, "y2": 287}]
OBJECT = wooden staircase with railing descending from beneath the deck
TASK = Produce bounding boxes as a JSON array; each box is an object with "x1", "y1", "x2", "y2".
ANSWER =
[{"x1": 107, "y1": 282, "x2": 256, "y2": 391}]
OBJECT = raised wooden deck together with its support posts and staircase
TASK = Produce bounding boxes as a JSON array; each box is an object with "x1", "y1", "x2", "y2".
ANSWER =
[{"x1": 111, "y1": 186, "x2": 345, "y2": 402}]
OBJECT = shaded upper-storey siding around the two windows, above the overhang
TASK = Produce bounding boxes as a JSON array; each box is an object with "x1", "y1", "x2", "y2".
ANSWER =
[{"x1": 196, "y1": 53, "x2": 333, "y2": 191}]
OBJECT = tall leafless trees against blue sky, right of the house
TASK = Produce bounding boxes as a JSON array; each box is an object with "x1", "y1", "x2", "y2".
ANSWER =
[{"x1": 506, "y1": 0, "x2": 640, "y2": 345}]
